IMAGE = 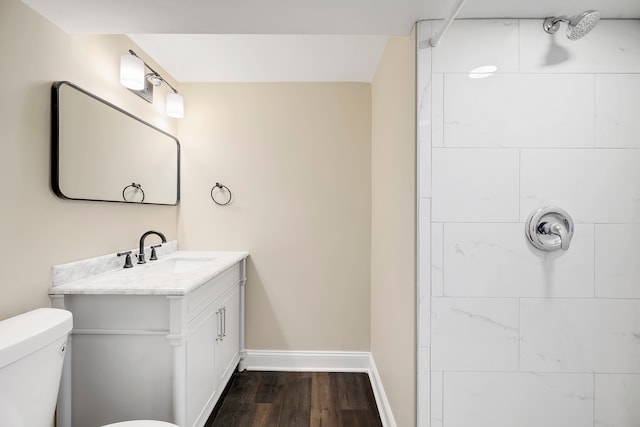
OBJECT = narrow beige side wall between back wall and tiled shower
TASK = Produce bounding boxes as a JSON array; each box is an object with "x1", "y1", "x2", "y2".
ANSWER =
[{"x1": 371, "y1": 34, "x2": 416, "y2": 427}]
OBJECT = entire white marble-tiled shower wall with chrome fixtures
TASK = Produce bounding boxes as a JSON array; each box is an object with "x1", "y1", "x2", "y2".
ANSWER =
[{"x1": 416, "y1": 7, "x2": 640, "y2": 427}]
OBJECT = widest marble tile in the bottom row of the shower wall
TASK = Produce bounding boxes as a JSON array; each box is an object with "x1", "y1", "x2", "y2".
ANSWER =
[{"x1": 443, "y1": 372, "x2": 593, "y2": 427}]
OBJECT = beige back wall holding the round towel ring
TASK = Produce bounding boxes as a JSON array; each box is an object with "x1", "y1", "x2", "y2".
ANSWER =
[{"x1": 179, "y1": 83, "x2": 371, "y2": 351}]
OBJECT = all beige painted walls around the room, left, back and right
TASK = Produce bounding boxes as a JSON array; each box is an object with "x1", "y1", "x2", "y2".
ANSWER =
[{"x1": 0, "y1": 0, "x2": 415, "y2": 426}]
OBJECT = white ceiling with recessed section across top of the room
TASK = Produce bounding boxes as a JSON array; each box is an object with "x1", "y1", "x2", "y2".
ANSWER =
[{"x1": 23, "y1": 0, "x2": 640, "y2": 82}]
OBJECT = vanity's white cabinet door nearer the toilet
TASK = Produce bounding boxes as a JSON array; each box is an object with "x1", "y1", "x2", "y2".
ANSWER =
[{"x1": 186, "y1": 310, "x2": 219, "y2": 426}]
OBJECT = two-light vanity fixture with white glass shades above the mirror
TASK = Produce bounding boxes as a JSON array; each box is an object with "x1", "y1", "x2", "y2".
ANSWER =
[{"x1": 120, "y1": 49, "x2": 184, "y2": 119}]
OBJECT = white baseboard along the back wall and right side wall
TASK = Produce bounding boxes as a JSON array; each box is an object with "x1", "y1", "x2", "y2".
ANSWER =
[{"x1": 243, "y1": 350, "x2": 396, "y2": 427}]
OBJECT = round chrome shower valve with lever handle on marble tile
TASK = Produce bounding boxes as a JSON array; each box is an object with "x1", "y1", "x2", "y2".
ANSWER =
[{"x1": 525, "y1": 206, "x2": 573, "y2": 252}]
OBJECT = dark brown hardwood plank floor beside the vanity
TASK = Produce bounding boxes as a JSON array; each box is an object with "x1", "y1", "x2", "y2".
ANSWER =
[{"x1": 205, "y1": 371, "x2": 382, "y2": 427}]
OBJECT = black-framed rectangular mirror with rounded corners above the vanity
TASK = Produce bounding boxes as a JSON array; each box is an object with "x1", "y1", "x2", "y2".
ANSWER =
[{"x1": 51, "y1": 81, "x2": 180, "y2": 205}]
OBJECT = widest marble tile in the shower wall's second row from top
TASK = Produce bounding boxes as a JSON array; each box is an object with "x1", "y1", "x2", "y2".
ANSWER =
[{"x1": 444, "y1": 74, "x2": 594, "y2": 148}]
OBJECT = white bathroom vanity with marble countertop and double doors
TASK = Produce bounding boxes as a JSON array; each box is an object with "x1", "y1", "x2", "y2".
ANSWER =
[{"x1": 49, "y1": 251, "x2": 248, "y2": 427}]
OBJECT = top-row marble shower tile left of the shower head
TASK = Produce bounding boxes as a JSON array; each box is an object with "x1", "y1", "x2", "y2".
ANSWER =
[{"x1": 432, "y1": 19, "x2": 518, "y2": 74}]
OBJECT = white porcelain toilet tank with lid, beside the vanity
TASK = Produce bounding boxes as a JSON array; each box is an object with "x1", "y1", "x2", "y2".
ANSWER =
[{"x1": 0, "y1": 308, "x2": 72, "y2": 427}]
